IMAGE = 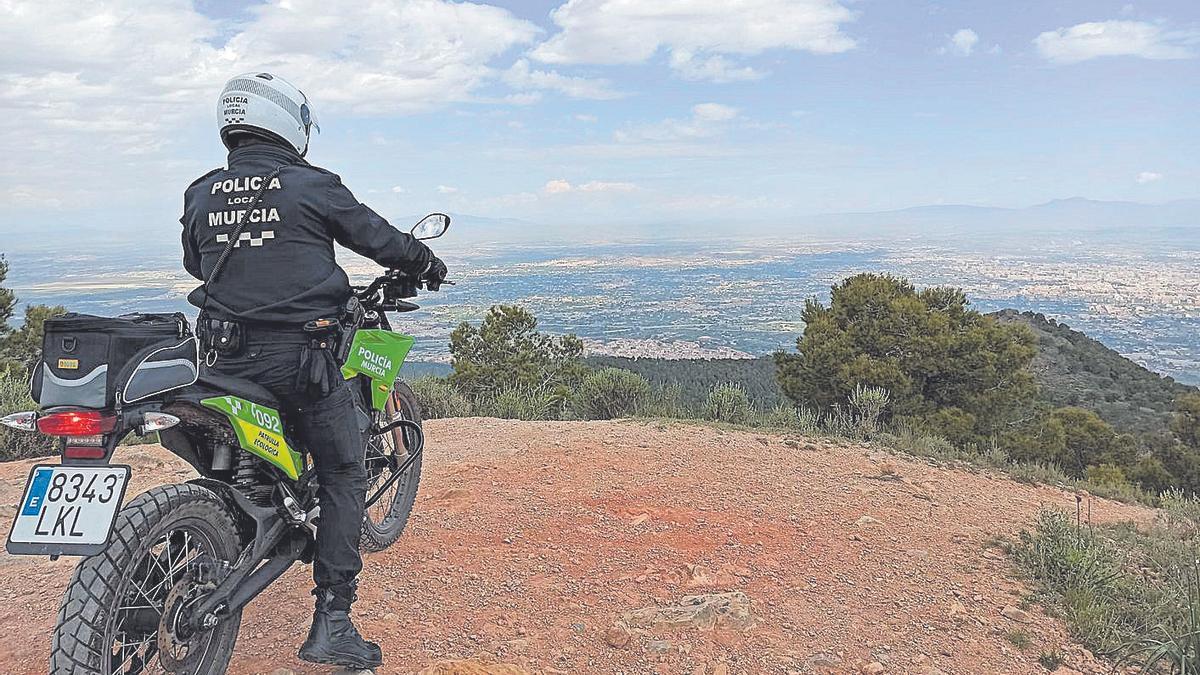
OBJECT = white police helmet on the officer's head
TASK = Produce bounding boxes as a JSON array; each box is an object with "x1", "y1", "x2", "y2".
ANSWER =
[{"x1": 217, "y1": 72, "x2": 320, "y2": 155}]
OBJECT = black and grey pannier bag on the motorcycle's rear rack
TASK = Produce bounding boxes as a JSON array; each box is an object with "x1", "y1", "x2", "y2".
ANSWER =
[{"x1": 30, "y1": 312, "x2": 199, "y2": 408}]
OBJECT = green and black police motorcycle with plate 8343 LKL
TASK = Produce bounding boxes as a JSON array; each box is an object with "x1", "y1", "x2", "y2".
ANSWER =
[{"x1": 0, "y1": 214, "x2": 450, "y2": 675}]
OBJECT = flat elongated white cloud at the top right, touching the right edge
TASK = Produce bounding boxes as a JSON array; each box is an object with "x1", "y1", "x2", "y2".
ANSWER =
[{"x1": 1033, "y1": 20, "x2": 1200, "y2": 64}]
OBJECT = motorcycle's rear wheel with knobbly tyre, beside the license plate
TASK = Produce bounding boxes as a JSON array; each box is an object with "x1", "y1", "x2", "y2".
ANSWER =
[{"x1": 50, "y1": 484, "x2": 241, "y2": 675}]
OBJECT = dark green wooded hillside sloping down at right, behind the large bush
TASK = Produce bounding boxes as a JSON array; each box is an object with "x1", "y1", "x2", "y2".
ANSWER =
[{"x1": 991, "y1": 310, "x2": 1195, "y2": 434}]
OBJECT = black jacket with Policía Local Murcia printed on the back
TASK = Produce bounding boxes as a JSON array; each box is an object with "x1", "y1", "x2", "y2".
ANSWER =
[{"x1": 179, "y1": 143, "x2": 432, "y2": 325}]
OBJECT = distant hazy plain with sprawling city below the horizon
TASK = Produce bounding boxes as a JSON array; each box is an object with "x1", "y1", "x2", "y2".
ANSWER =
[{"x1": 7, "y1": 225, "x2": 1200, "y2": 383}]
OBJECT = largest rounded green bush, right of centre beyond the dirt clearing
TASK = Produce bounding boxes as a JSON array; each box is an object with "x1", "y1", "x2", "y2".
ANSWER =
[{"x1": 775, "y1": 274, "x2": 1036, "y2": 441}]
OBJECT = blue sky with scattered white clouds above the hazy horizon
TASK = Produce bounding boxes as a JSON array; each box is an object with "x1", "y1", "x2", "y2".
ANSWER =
[{"x1": 0, "y1": 0, "x2": 1200, "y2": 241}]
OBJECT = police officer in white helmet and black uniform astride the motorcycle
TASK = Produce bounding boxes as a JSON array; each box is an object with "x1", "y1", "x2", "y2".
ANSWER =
[{"x1": 180, "y1": 72, "x2": 446, "y2": 668}]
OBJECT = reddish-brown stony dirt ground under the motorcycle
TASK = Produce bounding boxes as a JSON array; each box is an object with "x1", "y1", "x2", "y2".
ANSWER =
[{"x1": 0, "y1": 419, "x2": 1152, "y2": 675}]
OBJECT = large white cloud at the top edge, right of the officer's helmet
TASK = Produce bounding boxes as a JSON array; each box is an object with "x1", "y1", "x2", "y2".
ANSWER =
[{"x1": 532, "y1": 0, "x2": 854, "y2": 82}]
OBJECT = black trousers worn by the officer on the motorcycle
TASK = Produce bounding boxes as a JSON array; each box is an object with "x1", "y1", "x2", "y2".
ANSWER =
[{"x1": 212, "y1": 341, "x2": 367, "y2": 609}]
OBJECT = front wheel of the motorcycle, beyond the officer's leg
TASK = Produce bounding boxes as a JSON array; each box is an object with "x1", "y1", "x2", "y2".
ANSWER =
[{"x1": 359, "y1": 382, "x2": 421, "y2": 552}]
